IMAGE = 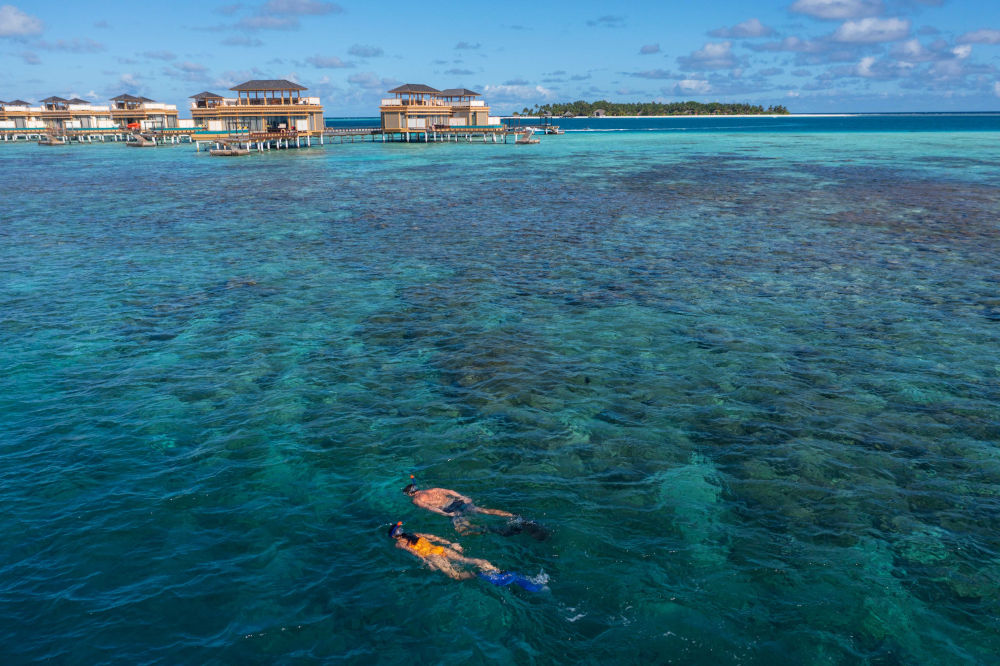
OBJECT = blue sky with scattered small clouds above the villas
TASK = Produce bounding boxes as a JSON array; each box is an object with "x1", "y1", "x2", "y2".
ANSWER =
[{"x1": 0, "y1": 0, "x2": 1000, "y2": 117}]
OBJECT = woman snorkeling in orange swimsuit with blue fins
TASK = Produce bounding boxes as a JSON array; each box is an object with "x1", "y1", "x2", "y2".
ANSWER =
[{"x1": 389, "y1": 521, "x2": 548, "y2": 592}]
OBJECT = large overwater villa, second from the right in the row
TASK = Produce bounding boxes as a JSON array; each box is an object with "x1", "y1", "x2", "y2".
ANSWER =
[{"x1": 191, "y1": 79, "x2": 324, "y2": 137}]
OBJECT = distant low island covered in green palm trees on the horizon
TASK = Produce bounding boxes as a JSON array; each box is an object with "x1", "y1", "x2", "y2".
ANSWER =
[{"x1": 513, "y1": 99, "x2": 788, "y2": 116}]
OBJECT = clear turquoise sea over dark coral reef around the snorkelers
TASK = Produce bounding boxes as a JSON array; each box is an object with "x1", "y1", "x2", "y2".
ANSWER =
[{"x1": 0, "y1": 116, "x2": 1000, "y2": 665}]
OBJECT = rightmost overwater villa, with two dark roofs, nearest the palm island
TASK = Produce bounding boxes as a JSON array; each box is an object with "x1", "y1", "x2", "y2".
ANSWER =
[{"x1": 379, "y1": 83, "x2": 502, "y2": 135}]
